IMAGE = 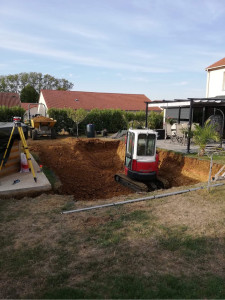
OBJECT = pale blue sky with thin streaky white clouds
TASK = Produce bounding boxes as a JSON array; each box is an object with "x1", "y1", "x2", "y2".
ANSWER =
[{"x1": 0, "y1": 0, "x2": 225, "y2": 100}]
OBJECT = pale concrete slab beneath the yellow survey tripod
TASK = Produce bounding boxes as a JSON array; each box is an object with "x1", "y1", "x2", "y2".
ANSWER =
[{"x1": 0, "y1": 156, "x2": 52, "y2": 198}]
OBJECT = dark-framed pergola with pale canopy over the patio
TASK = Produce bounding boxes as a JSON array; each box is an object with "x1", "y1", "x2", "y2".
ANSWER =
[{"x1": 145, "y1": 96, "x2": 225, "y2": 153}]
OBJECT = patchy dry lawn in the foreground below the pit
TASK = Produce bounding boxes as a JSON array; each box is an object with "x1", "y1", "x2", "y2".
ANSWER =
[{"x1": 0, "y1": 182, "x2": 225, "y2": 299}]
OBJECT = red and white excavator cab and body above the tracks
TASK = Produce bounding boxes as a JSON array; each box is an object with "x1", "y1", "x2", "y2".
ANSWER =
[{"x1": 125, "y1": 129, "x2": 159, "y2": 182}]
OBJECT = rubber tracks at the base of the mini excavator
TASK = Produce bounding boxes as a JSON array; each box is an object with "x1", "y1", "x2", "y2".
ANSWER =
[{"x1": 114, "y1": 174, "x2": 169, "y2": 193}]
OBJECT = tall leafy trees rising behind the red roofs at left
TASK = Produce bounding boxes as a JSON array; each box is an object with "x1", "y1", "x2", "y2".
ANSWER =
[{"x1": 0, "y1": 72, "x2": 73, "y2": 94}]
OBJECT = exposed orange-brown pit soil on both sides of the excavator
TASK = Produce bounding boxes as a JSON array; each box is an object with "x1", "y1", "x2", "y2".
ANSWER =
[{"x1": 29, "y1": 137, "x2": 221, "y2": 200}]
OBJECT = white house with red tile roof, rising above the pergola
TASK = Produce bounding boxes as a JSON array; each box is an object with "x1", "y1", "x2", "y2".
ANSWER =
[{"x1": 205, "y1": 57, "x2": 225, "y2": 98}]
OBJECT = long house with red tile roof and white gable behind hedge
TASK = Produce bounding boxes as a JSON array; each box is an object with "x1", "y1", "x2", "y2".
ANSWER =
[{"x1": 39, "y1": 90, "x2": 161, "y2": 114}]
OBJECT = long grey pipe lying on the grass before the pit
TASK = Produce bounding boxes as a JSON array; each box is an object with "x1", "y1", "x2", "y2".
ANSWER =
[{"x1": 61, "y1": 183, "x2": 225, "y2": 214}]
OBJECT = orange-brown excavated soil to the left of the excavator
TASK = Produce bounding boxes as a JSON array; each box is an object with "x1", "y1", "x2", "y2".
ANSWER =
[{"x1": 29, "y1": 138, "x2": 132, "y2": 200}]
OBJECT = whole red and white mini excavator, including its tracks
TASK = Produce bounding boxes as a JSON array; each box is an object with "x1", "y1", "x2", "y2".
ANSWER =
[{"x1": 114, "y1": 129, "x2": 169, "y2": 192}]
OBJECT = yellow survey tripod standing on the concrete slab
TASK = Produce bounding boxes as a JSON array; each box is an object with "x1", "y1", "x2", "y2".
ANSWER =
[{"x1": 0, "y1": 117, "x2": 37, "y2": 182}]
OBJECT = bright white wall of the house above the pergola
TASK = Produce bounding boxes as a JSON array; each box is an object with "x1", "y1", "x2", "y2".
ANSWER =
[{"x1": 206, "y1": 68, "x2": 225, "y2": 97}]
